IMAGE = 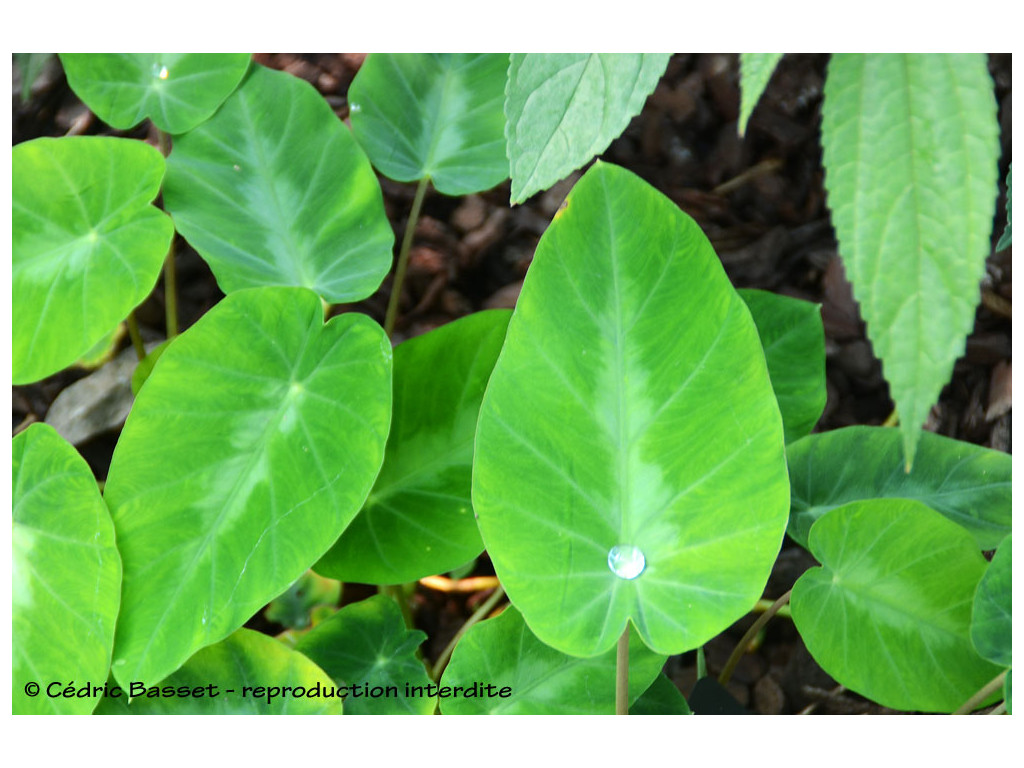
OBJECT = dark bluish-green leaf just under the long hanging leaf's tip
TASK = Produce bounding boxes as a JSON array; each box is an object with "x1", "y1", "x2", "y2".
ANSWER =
[{"x1": 786, "y1": 426, "x2": 1012, "y2": 550}]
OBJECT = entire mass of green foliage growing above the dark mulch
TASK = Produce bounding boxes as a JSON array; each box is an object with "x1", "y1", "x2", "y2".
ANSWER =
[{"x1": 12, "y1": 54, "x2": 1012, "y2": 714}]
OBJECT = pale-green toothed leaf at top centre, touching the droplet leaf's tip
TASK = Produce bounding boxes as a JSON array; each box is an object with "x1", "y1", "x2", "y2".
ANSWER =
[{"x1": 505, "y1": 53, "x2": 669, "y2": 204}]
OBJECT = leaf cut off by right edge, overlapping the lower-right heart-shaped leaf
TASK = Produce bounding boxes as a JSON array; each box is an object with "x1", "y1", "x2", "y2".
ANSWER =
[{"x1": 971, "y1": 536, "x2": 1013, "y2": 667}]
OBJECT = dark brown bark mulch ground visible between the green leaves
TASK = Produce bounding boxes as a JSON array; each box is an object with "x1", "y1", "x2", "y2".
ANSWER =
[{"x1": 12, "y1": 53, "x2": 1012, "y2": 714}]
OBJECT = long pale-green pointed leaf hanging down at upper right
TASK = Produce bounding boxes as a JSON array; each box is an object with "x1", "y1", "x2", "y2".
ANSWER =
[{"x1": 821, "y1": 53, "x2": 999, "y2": 467}]
